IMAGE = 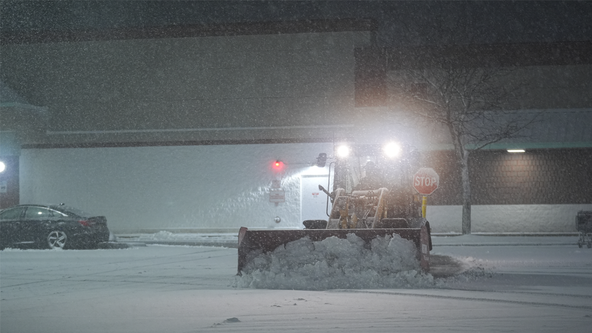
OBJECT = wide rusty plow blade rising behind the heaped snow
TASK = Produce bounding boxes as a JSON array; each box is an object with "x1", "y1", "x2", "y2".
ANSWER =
[{"x1": 238, "y1": 224, "x2": 431, "y2": 275}]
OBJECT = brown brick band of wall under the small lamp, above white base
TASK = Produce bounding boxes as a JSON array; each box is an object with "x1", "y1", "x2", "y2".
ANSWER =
[{"x1": 423, "y1": 148, "x2": 592, "y2": 205}]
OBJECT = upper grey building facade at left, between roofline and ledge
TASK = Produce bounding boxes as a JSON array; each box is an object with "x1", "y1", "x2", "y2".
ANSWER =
[{"x1": 1, "y1": 31, "x2": 369, "y2": 144}]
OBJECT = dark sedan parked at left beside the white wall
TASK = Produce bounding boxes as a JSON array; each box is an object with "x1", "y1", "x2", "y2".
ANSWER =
[{"x1": 0, "y1": 205, "x2": 109, "y2": 249}]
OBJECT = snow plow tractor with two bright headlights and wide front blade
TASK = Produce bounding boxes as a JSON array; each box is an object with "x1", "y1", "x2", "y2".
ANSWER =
[{"x1": 238, "y1": 143, "x2": 432, "y2": 275}]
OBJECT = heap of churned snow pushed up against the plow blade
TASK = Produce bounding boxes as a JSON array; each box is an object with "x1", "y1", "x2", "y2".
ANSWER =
[{"x1": 236, "y1": 234, "x2": 435, "y2": 290}]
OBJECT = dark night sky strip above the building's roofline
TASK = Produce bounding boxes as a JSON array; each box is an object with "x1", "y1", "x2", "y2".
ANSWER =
[{"x1": 0, "y1": 1, "x2": 592, "y2": 46}]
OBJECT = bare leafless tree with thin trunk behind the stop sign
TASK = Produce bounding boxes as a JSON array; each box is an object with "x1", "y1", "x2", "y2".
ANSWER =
[{"x1": 391, "y1": 62, "x2": 534, "y2": 234}]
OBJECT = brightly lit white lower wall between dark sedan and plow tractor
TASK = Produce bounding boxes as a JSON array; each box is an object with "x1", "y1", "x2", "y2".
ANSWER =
[{"x1": 20, "y1": 143, "x2": 332, "y2": 232}]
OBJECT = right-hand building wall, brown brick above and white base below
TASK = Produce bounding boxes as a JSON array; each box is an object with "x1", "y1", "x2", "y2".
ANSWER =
[{"x1": 422, "y1": 148, "x2": 592, "y2": 233}]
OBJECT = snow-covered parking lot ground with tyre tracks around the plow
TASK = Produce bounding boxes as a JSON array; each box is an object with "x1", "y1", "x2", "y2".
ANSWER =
[{"x1": 0, "y1": 236, "x2": 592, "y2": 333}]
